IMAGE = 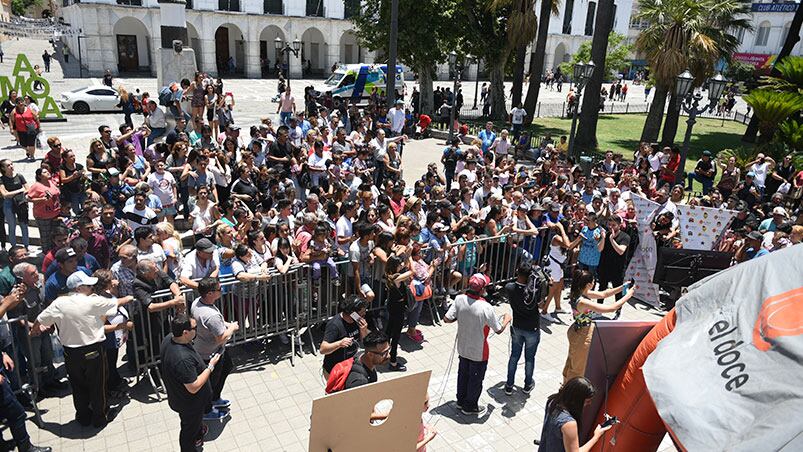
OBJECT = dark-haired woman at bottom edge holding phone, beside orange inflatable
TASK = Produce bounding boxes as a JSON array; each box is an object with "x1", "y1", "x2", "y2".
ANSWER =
[{"x1": 538, "y1": 377, "x2": 612, "y2": 452}]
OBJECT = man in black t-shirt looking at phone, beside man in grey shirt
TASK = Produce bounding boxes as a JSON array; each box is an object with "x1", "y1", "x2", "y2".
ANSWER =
[{"x1": 161, "y1": 311, "x2": 220, "y2": 452}]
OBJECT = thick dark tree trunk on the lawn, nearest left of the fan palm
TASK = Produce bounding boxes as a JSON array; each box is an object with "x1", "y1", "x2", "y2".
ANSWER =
[{"x1": 574, "y1": 0, "x2": 613, "y2": 155}]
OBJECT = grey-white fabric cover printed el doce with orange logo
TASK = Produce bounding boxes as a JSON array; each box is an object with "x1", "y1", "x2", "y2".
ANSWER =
[{"x1": 643, "y1": 245, "x2": 803, "y2": 452}]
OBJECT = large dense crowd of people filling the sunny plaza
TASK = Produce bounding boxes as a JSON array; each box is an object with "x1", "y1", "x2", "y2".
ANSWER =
[{"x1": 0, "y1": 68, "x2": 803, "y2": 450}]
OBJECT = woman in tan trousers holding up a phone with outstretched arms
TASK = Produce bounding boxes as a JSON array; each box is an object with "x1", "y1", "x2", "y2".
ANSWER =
[{"x1": 563, "y1": 270, "x2": 635, "y2": 383}]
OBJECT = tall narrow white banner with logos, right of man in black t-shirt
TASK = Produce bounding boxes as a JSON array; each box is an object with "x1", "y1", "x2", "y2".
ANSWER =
[{"x1": 625, "y1": 194, "x2": 660, "y2": 306}]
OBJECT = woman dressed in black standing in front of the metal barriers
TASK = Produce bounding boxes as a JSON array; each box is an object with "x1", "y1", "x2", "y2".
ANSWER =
[{"x1": 385, "y1": 255, "x2": 413, "y2": 372}]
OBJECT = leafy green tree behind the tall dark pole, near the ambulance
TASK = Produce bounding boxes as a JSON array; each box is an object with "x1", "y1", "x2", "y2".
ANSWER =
[{"x1": 352, "y1": 0, "x2": 457, "y2": 114}]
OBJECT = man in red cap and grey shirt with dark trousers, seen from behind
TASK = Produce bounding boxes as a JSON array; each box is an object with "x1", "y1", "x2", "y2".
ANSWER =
[{"x1": 444, "y1": 273, "x2": 511, "y2": 417}]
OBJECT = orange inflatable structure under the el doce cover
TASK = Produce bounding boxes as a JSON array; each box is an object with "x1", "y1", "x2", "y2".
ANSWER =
[{"x1": 592, "y1": 309, "x2": 676, "y2": 452}]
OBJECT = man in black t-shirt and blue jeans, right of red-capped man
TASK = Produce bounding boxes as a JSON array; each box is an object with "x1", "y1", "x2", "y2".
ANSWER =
[{"x1": 505, "y1": 262, "x2": 541, "y2": 395}]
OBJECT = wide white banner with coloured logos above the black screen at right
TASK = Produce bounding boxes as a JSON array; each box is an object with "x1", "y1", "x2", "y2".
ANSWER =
[{"x1": 677, "y1": 204, "x2": 736, "y2": 251}]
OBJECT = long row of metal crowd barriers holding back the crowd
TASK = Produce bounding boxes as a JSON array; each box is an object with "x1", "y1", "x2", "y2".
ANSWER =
[{"x1": 127, "y1": 228, "x2": 551, "y2": 398}]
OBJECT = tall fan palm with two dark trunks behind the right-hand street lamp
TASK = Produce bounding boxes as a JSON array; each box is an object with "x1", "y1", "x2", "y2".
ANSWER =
[{"x1": 636, "y1": 0, "x2": 751, "y2": 142}]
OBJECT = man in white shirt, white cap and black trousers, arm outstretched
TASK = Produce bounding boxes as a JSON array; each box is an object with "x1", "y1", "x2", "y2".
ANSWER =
[{"x1": 31, "y1": 270, "x2": 133, "y2": 428}]
